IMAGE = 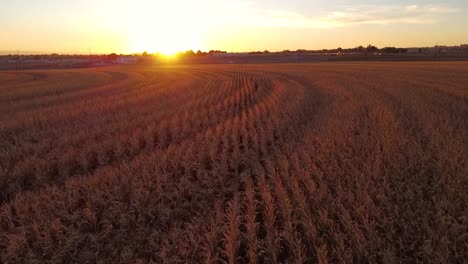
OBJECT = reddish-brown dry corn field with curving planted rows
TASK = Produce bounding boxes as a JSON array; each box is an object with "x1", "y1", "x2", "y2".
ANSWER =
[{"x1": 0, "y1": 62, "x2": 468, "y2": 263}]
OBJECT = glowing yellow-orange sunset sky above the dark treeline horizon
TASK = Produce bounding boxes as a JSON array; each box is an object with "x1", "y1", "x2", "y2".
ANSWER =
[{"x1": 0, "y1": 0, "x2": 468, "y2": 53}]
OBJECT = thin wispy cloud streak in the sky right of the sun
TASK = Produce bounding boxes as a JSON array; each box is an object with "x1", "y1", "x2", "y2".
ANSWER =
[{"x1": 225, "y1": 2, "x2": 461, "y2": 28}]
